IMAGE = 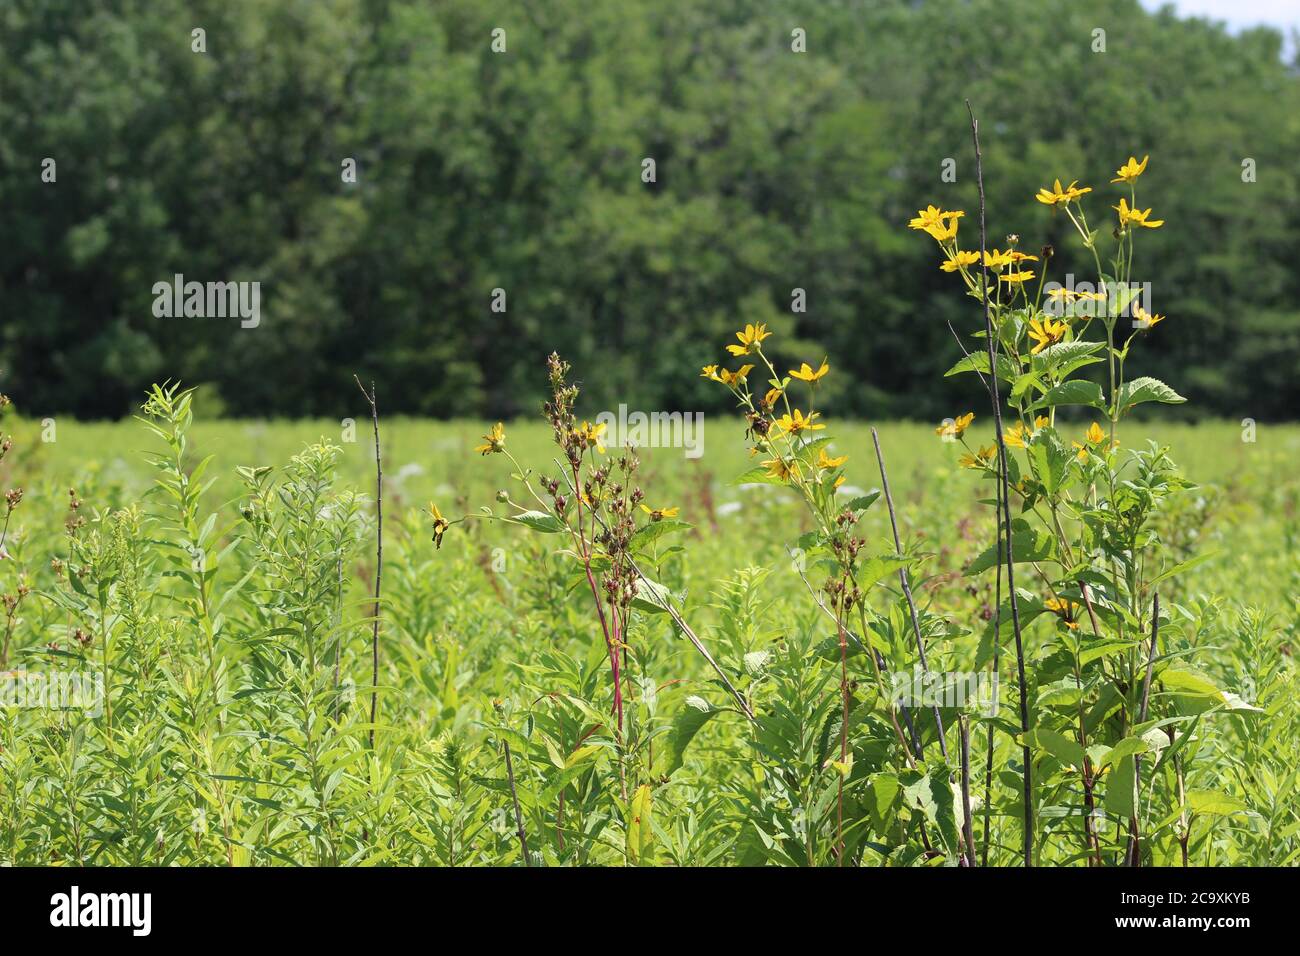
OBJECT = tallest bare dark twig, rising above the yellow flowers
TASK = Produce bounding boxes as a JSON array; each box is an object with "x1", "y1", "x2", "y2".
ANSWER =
[{"x1": 966, "y1": 100, "x2": 1034, "y2": 866}]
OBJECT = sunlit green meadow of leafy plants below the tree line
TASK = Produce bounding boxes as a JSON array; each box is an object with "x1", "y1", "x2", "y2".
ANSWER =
[{"x1": 0, "y1": 403, "x2": 1300, "y2": 865}]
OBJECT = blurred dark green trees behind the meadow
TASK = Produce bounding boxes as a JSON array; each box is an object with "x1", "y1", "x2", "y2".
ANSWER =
[{"x1": 0, "y1": 0, "x2": 1300, "y2": 419}]
